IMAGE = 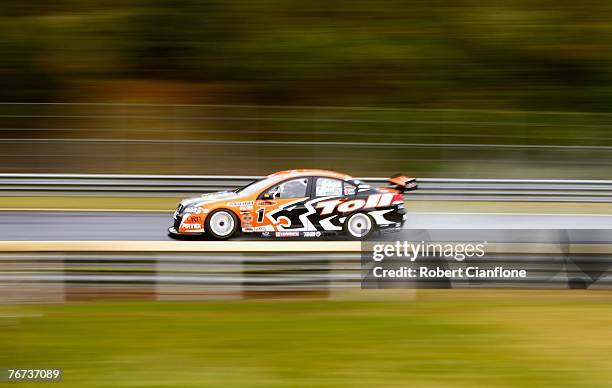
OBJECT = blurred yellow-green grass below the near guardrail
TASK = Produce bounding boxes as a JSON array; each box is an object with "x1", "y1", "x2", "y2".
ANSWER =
[{"x1": 0, "y1": 290, "x2": 612, "y2": 387}]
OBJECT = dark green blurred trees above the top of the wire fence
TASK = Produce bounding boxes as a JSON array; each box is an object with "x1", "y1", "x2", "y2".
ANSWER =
[{"x1": 0, "y1": 0, "x2": 612, "y2": 111}]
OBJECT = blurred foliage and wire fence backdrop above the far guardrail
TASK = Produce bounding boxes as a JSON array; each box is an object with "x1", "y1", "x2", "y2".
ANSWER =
[{"x1": 0, "y1": 0, "x2": 612, "y2": 178}]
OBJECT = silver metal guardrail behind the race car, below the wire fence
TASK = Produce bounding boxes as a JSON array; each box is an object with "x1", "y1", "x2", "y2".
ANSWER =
[{"x1": 0, "y1": 173, "x2": 612, "y2": 202}]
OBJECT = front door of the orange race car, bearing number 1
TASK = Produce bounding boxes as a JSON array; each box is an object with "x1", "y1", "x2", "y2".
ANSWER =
[{"x1": 252, "y1": 177, "x2": 314, "y2": 233}]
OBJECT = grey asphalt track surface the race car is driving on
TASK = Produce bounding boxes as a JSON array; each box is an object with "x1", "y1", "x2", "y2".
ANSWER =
[{"x1": 0, "y1": 211, "x2": 612, "y2": 241}]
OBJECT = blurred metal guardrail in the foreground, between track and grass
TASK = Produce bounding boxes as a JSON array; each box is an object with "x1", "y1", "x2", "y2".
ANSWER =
[{"x1": 0, "y1": 241, "x2": 612, "y2": 303}]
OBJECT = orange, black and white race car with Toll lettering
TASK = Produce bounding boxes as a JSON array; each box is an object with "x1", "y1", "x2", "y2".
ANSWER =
[{"x1": 168, "y1": 169, "x2": 417, "y2": 240}]
